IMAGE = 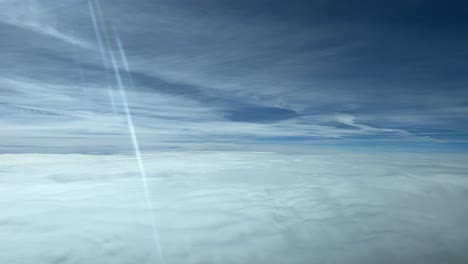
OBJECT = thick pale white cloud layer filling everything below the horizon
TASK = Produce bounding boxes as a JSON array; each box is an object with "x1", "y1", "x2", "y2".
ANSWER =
[{"x1": 0, "y1": 152, "x2": 468, "y2": 264}]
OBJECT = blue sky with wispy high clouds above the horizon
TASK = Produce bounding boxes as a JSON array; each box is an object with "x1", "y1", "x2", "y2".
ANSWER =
[{"x1": 0, "y1": 0, "x2": 468, "y2": 153}]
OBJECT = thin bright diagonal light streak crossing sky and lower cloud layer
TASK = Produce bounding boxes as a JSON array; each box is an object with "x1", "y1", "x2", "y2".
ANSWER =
[{"x1": 88, "y1": 0, "x2": 165, "y2": 263}]
